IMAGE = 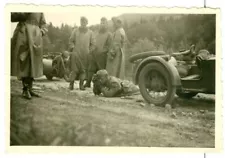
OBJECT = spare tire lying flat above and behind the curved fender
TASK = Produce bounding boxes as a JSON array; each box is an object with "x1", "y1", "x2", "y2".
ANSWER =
[{"x1": 129, "y1": 51, "x2": 166, "y2": 63}]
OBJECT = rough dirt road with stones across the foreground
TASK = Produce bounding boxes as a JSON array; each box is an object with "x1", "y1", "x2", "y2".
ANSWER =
[{"x1": 11, "y1": 78, "x2": 215, "y2": 148}]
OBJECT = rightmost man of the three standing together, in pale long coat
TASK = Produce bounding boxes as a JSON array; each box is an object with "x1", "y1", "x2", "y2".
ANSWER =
[{"x1": 106, "y1": 18, "x2": 126, "y2": 79}]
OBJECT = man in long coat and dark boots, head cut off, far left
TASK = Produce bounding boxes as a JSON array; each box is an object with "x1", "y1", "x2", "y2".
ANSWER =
[{"x1": 11, "y1": 13, "x2": 47, "y2": 99}]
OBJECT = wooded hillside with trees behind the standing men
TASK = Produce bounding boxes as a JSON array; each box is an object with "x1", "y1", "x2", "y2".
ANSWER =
[{"x1": 44, "y1": 14, "x2": 216, "y2": 77}]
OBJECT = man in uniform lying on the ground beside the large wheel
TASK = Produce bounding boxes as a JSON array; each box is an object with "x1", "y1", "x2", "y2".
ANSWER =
[{"x1": 92, "y1": 70, "x2": 139, "y2": 97}]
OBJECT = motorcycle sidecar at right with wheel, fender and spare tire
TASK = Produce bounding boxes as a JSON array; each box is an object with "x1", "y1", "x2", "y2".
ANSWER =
[{"x1": 130, "y1": 51, "x2": 215, "y2": 105}]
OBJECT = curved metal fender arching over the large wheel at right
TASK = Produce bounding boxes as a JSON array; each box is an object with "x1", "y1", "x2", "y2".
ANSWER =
[{"x1": 133, "y1": 56, "x2": 181, "y2": 86}]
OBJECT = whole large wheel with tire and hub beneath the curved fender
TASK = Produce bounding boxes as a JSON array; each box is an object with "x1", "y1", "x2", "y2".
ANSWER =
[{"x1": 138, "y1": 62, "x2": 176, "y2": 106}]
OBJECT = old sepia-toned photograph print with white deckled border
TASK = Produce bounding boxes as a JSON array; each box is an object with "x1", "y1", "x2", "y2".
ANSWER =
[{"x1": 7, "y1": 5, "x2": 222, "y2": 149}]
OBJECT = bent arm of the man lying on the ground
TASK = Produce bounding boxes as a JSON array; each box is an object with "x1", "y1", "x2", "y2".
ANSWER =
[{"x1": 101, "y1": 82, "x2": 121, "y2": 97}]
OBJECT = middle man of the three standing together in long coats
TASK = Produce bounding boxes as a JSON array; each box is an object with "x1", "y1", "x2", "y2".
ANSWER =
[{"x1": 85, "y1": 17, "x2": 112, "y2": 87}]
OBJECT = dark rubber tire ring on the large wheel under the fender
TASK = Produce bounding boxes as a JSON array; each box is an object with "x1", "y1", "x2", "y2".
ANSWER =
[{"x1": 138, "y1": 62, "x2": 176, "y2": 106}]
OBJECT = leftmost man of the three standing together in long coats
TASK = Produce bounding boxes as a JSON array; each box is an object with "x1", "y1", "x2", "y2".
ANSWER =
[{"x1": 69, "y1": 17, "x2": 95, "y2": 90}]
